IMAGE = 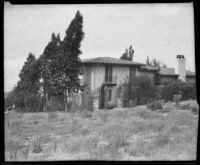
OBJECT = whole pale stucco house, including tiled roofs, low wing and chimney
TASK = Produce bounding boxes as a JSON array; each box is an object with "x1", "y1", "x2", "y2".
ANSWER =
[{"x1": 82, "y1": 55, "x2": 196, "y2": 108}]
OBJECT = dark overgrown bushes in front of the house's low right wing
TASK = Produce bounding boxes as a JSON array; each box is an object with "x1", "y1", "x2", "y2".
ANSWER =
[{"x1": 118, "y1": 76, "x2": 196, "y2": 107}]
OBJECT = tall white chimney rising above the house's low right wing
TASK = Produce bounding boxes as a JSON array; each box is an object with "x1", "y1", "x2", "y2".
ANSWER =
[{"x1": 175, "y1": 55, "x2": 186, "y2": 81}]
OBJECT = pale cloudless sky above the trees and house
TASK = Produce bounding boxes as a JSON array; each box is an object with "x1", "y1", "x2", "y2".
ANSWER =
[{"x1": 4, "y1": 2, "x2": 195, "y2": 92}]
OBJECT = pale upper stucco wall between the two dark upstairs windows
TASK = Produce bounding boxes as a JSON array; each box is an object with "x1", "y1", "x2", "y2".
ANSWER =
[{"x1": 113, "y1": 66, "x2": 129, "y2": 86}]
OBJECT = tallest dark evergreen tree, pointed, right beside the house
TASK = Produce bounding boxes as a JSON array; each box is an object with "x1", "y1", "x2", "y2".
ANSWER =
[{"x1": 51, "y1": 11, "x2": 84, "y2": 111}]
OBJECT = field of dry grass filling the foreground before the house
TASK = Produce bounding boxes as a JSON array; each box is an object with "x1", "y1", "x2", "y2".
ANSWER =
[{"x1": 5, "y1": 100, "x2": 198, "y2": 161}]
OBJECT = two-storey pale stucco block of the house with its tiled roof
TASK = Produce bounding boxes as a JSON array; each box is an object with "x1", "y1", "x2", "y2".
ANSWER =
[{"x1": 82, "y1": 57, "x2": 145, "y2": 108}]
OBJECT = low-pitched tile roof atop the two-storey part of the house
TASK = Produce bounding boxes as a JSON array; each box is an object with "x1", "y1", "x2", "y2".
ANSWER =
[{"x1": 81, "y1": 57, "x2": 145, "y2": 66}]
